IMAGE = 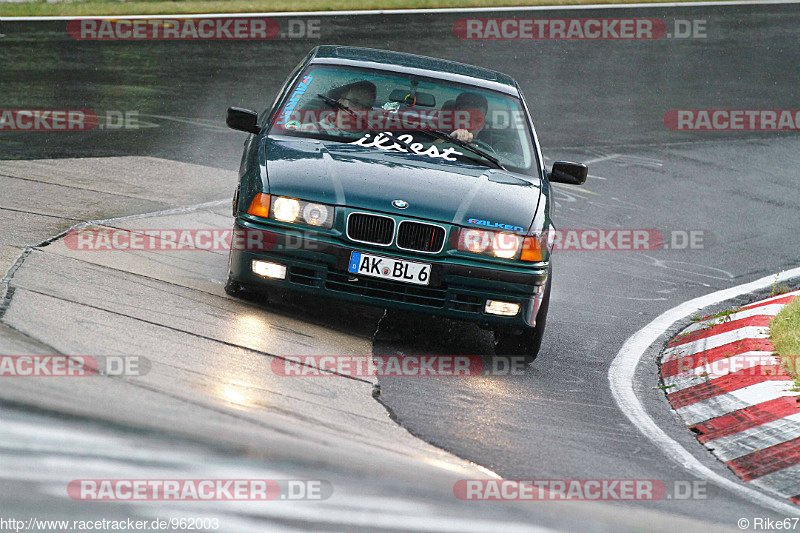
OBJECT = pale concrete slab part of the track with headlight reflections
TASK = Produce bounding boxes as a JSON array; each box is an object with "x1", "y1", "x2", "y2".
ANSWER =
[{"x1": 0, "y1": 163, "x2": 740, "y2": 531}]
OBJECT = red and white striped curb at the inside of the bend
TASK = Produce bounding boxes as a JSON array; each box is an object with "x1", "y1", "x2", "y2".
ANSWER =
[{"x1": 660, "y1": 291, "x2": 800, "y2": 503}]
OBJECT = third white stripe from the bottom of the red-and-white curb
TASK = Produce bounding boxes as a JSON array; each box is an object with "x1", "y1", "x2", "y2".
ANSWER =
[{"x1": 675, "y1": 379, "x2": 800, "y2": 426}]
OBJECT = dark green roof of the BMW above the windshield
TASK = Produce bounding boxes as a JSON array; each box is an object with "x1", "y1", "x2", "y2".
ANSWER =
[{"x1": 310, "y1": 46, "x2": 518, "y2": 95}]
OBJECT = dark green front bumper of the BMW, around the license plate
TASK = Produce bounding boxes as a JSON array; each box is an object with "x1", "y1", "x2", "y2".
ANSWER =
[{"x1": 229, "y1": 219, "x2": 548, "y2": 328}]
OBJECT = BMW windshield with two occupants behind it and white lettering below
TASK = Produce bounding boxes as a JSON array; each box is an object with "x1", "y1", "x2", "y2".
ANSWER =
[{"x1": 270, "y1": 65, "x2": 536, "y2": 174}]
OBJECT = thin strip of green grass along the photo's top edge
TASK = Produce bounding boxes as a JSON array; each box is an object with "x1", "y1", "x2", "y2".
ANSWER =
[{"x1": 0, "y1": 0, "x2": 728, "y2": 17}]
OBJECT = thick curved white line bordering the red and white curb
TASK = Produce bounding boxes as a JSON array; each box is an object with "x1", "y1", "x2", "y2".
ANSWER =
[{"x1": 608, "y1": 268, "x2": 800, "y2": 516}]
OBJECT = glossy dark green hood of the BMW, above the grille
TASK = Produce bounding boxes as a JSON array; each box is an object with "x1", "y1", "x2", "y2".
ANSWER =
[{"x1": 265, "y1": 136, "x2": 541, "y2": 230}]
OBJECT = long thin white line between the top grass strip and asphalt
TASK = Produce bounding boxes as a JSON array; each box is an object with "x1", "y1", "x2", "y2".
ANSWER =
[{"x1": 6, "y1": 0, "x2": 800, "y2": 21}]
